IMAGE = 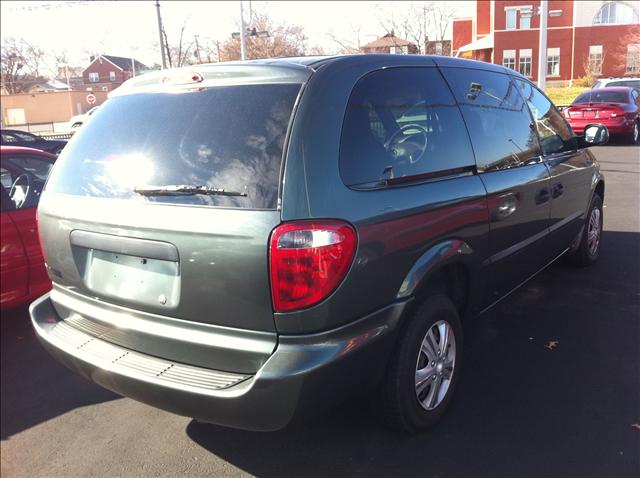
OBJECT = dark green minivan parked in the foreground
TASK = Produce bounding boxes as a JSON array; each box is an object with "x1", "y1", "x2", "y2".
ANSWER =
[{"x1": 30, "y1": 55, "x2": 607, "y2": 431}]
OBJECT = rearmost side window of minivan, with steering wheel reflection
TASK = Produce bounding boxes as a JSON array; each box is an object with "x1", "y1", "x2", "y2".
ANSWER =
[{"x1": 340, "y1": 68, "x2": 474, "y2": 187}]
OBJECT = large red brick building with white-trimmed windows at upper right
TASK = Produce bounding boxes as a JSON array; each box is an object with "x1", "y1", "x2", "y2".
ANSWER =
[{"x1": 452, "y1": 0, "x2": 640, "y2": 84}]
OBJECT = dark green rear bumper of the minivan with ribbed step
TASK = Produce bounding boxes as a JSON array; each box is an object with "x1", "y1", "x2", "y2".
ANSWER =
[{"x1": 29, "y1": 294, "x2": 408, "y2": 431}]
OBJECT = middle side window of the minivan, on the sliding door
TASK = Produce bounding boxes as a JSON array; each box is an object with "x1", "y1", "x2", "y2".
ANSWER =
[{"x1": 443, "y1": 68, "x2": 540, "y2": 171}]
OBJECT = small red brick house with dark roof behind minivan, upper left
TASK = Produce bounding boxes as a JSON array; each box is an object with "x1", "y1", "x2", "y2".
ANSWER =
[{"x1": 82, "y1": 55, "x2": 148, "y2": 91}]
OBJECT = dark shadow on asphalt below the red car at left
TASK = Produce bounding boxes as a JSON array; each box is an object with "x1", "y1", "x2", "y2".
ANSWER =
[{"x1": 0, "y1": 307, "x2": 121, "y2": 440}]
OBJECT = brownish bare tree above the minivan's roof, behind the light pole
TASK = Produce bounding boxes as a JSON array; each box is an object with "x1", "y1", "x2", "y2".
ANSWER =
[{"x1": 220, "y1": 11, "x2": 307, "y2": 61}]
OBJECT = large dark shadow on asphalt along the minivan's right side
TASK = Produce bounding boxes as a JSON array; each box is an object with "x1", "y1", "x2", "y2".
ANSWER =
[{"x1": 186, "y1": 231, "x2": 640, "y2": 477}]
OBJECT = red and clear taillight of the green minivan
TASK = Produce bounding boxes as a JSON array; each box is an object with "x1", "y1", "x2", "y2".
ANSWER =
[{"x1": 269, "y1": 220, "x2": 358, "y2": 312}]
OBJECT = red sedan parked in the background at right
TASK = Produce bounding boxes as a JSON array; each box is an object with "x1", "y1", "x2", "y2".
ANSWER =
[{"x1": 563, "y1": 86, "x2": 640, "y2": 144}]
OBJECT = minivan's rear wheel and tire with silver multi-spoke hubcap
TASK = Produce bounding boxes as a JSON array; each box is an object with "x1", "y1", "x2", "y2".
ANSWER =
[{"x1": 374, "y1": 294, "x2": 462, "y2": 433}]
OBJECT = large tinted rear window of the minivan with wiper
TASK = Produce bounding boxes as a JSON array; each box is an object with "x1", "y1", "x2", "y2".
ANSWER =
[{"x1": 47, "y1": 84, "x2": 301, "y2": 209}]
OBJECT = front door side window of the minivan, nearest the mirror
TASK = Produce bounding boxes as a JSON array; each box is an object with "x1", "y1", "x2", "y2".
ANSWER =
[{"x1": 514, "y1": 78, "x2": 576, "y2": 155}]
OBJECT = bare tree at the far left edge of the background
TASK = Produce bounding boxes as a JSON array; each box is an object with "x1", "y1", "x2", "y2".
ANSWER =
[{"x1": 0, "y1": 38, "x2": 44, "y2": 94}]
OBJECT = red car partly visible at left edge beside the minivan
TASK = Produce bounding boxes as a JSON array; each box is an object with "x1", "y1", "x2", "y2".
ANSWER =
[{"x1": 0, "y1": 146, "x2": 56, "y2": 309}]
